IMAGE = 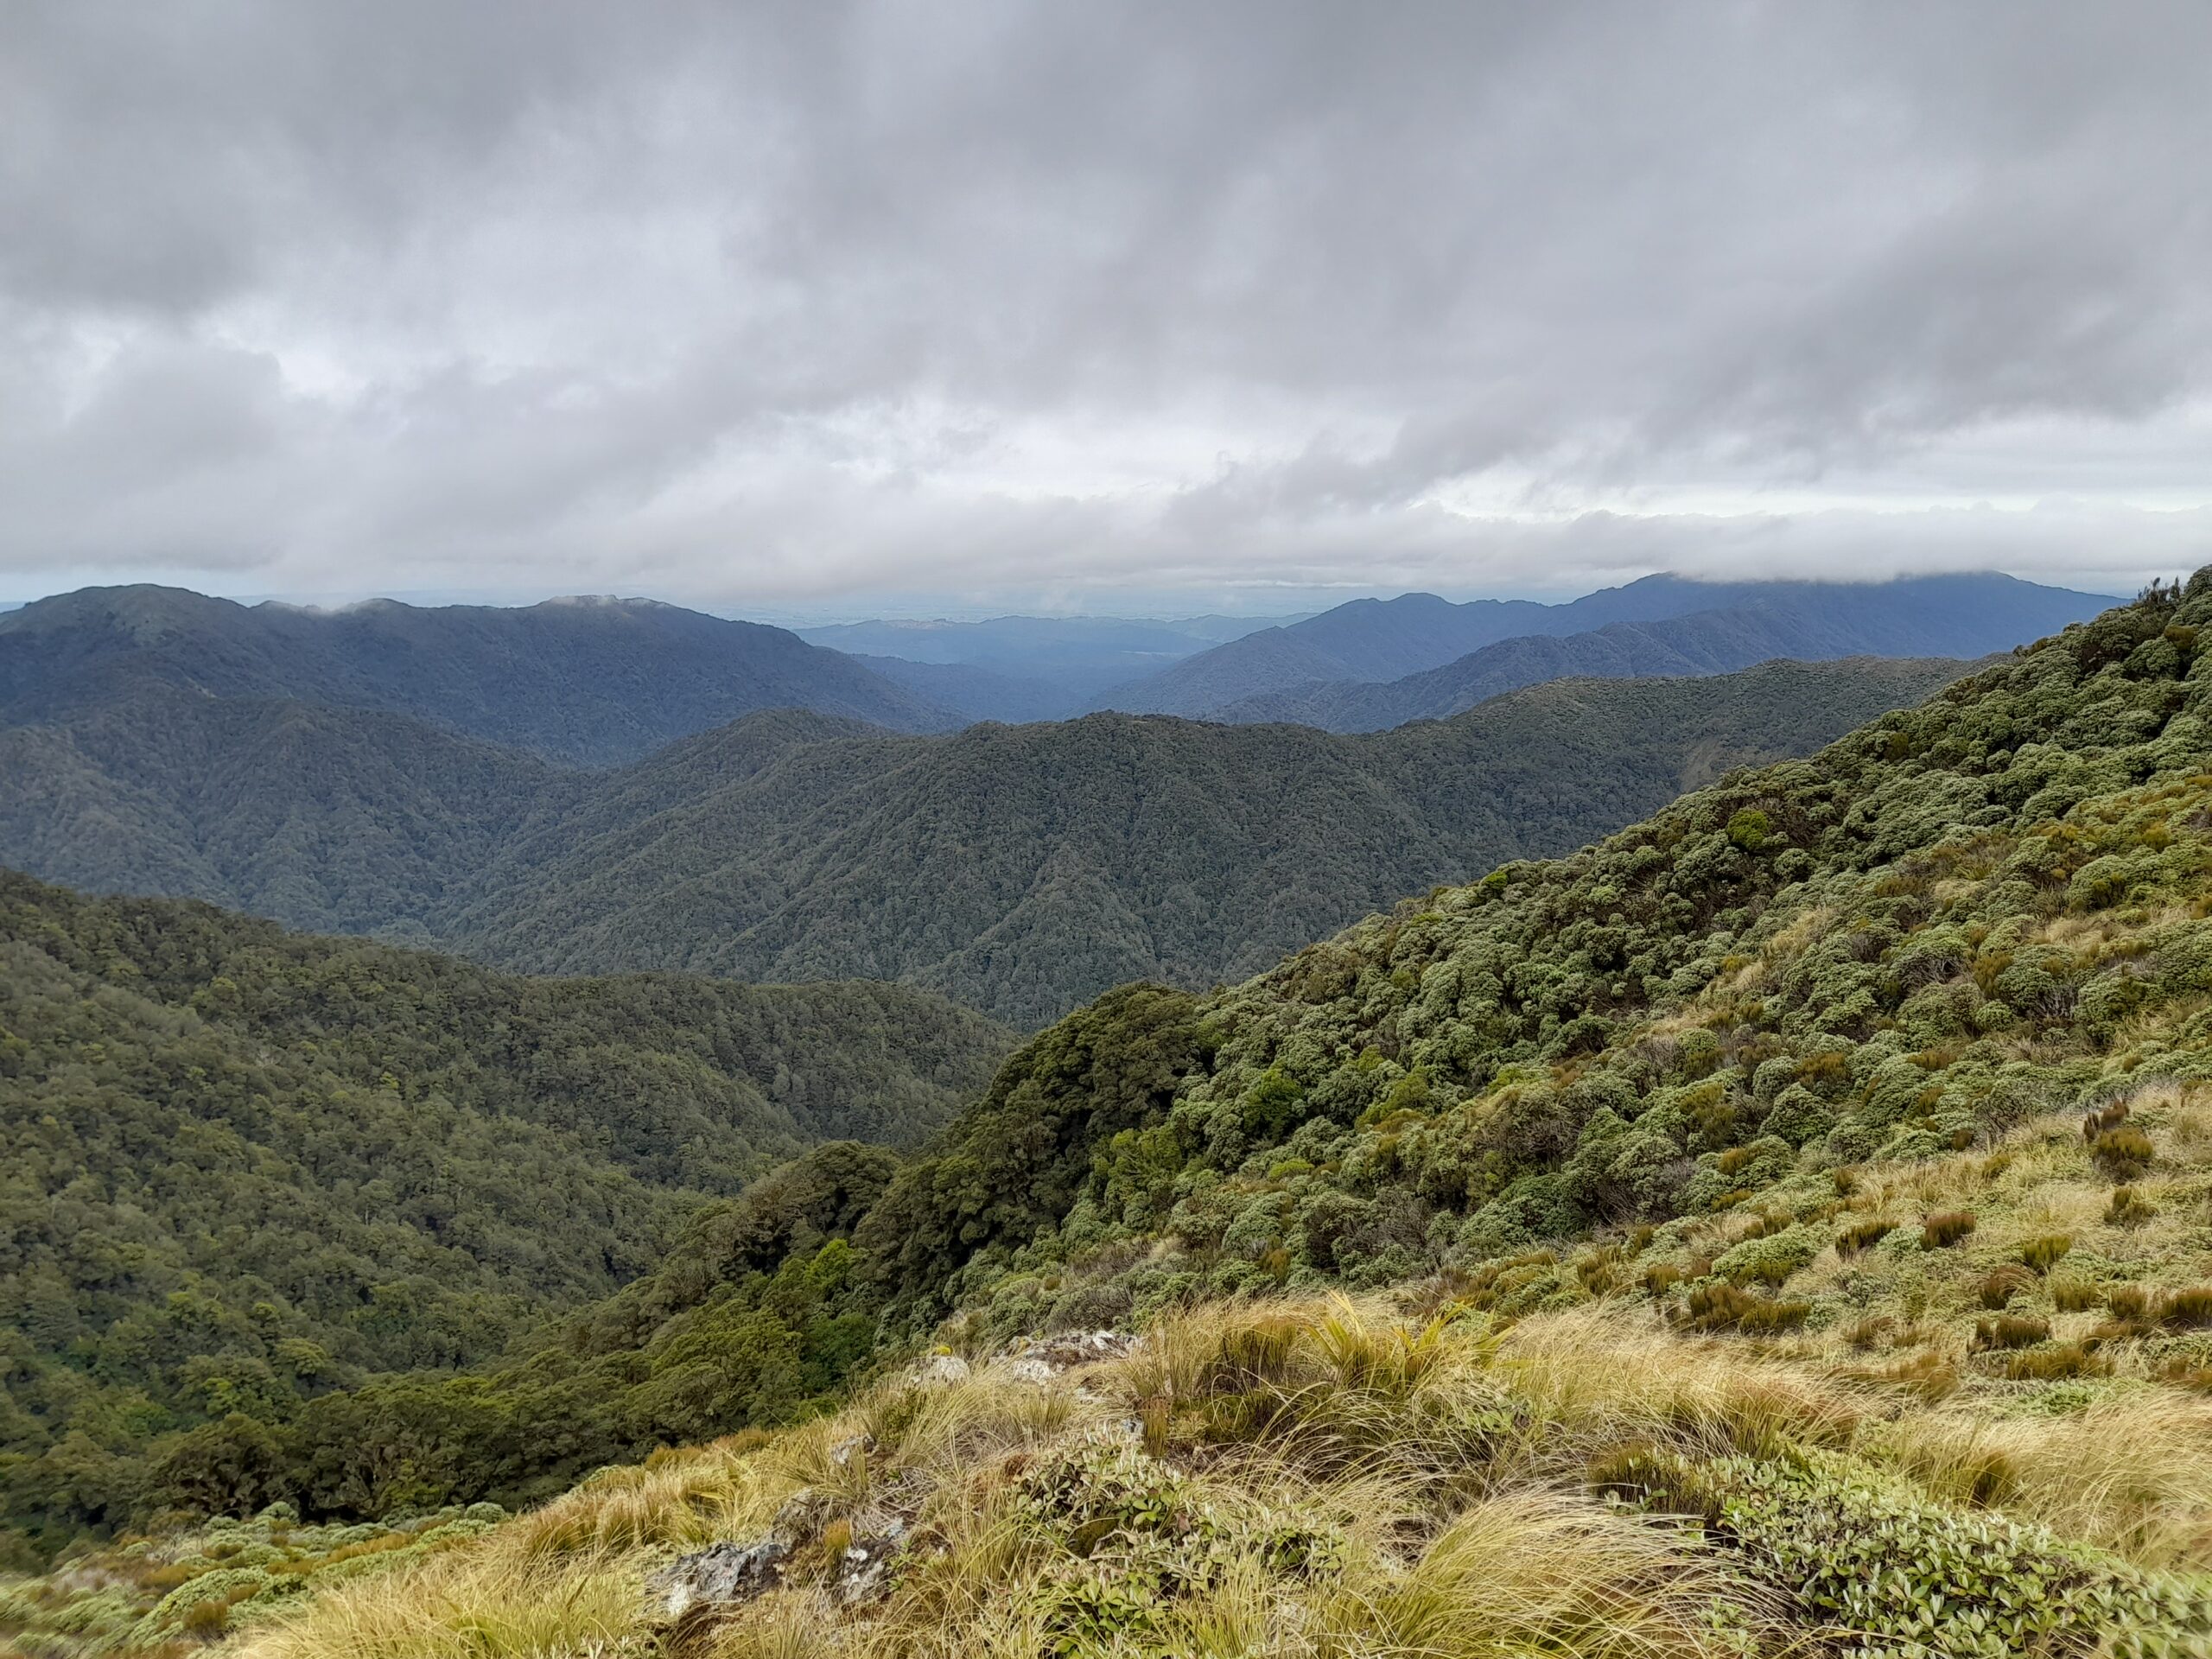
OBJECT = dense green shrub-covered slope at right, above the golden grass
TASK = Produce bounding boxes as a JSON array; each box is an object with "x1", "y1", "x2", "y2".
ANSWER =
[{"x1": 862, "y1": 570, "x2": 2212, "y2": 1336}]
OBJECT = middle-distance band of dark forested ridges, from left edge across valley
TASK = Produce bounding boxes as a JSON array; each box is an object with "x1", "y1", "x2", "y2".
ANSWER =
[{"x1": 0, "y1": 661, "x2": 1962, "y2": 1027}]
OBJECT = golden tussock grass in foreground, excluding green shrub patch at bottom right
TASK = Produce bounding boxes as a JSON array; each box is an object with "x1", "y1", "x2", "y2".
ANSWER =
[{"x1": 211, "y1": 1089, "x2": 2212, "y2": 1659}]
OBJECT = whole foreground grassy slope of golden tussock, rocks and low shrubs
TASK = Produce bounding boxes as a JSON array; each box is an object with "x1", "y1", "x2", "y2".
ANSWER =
[{"x1": 17, "y1": 1106, "x2": 2212, "y2": 1659}]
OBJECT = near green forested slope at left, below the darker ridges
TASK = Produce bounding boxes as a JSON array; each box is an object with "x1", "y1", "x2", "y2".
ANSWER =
[{"x1": 0, "y1": 874, "x2": 1007, "y2": 1537}]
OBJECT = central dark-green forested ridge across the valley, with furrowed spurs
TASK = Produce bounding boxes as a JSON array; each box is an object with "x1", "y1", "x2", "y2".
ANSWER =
[{"x1": 445, "y1": 661, "x2": 1960, "y2": 1024}]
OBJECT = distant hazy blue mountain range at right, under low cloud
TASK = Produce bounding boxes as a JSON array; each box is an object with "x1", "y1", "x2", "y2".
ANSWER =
[{"x1": 1103, "y1": 573, "x2": 2110, "y2": 732}]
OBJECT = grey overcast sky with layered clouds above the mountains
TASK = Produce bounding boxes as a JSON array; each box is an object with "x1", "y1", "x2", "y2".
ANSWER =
[{"x1": 0, "y1": 0, "x2": 2212, "y2": 615}]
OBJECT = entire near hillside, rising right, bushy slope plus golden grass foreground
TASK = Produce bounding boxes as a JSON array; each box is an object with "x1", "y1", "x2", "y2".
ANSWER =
[{"x1": 17, "y1": 570, "x2": 2212, "y2": 1659}]
